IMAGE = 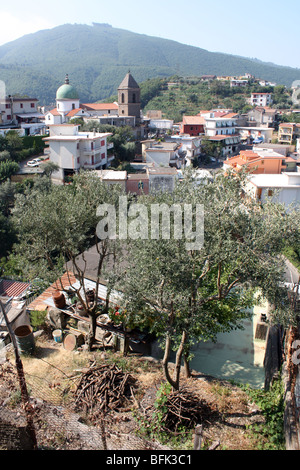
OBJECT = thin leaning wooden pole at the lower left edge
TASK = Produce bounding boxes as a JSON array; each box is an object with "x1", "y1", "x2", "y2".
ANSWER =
[{"x1": 0, "y1": 300, "x2": 37, "y2": 450}]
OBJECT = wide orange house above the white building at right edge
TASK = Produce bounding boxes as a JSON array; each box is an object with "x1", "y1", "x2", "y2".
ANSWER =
[{"x1": 223, "y1": 149, "x2": 297, "y2": 175}]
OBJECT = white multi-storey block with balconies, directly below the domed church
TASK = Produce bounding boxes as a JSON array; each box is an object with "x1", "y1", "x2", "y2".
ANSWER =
[{"x1": 43, "y1": 124, "x2": 114, "y2": 182}]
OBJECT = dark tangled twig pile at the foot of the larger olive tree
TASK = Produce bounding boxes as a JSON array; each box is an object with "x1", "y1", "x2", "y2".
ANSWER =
[{"x1": 161, "y1": 390, "x2": 216, "y2": 432}]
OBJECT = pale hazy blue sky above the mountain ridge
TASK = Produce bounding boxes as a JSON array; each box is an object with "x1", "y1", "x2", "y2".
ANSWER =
[{"x1": 0, "y1": 0, "x2": 300, "y2": 68}]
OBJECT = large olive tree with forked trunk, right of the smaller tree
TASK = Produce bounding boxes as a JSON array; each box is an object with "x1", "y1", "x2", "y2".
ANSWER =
[{"x1": 119, "y1": 169, "x2": 299, "y2": 389}]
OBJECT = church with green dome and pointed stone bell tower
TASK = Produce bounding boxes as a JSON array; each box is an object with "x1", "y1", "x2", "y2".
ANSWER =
[{"x1": 45, "y1": 72, "x2": 142, "y2": 128}]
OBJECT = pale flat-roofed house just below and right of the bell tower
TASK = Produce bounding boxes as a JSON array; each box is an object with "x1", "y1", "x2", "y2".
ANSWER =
[{"x1": 141, "y1": 140, "x2": 184, "y2": 168}]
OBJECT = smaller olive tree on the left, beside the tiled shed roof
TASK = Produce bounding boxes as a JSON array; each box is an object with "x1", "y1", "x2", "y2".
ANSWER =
[{"x1": 13, "y1": 172, "x2": 121, "y2": 346}]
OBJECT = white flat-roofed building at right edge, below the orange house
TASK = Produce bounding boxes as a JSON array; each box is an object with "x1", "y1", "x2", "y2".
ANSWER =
[{"x1": 247, "y1": 172, "x2": 300, "y2": 208}]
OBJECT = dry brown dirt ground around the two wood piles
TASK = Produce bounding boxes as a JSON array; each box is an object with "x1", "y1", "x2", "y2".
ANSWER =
[{"x1": 0, "y1": 337, "x2": 262, "y2": 450}]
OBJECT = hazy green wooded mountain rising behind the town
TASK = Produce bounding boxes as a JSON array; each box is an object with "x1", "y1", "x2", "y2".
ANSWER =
[{"x1": 0, "y1": 23, "x2": 300, "y2": 104}]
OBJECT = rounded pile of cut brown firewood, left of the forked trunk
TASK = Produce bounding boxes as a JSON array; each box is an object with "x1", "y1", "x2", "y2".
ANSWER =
[{"x1": 75, "y1": 364, "x2": 136, "y2": 416}]
